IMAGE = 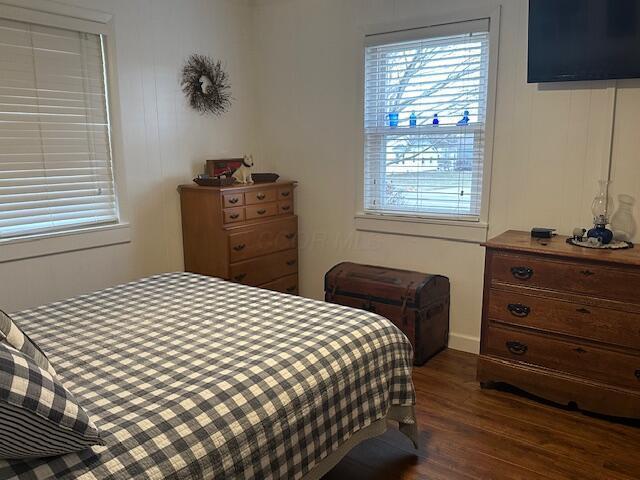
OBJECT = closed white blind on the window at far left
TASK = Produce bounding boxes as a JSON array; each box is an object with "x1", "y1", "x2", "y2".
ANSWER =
[{"x1": 0, "y1": 19, "x2": 118, "y2": 238}]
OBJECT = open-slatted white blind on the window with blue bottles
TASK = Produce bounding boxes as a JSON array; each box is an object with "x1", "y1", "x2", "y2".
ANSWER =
[{"x1": 364, "y1": 23, "x2": 489, "y2": 221}]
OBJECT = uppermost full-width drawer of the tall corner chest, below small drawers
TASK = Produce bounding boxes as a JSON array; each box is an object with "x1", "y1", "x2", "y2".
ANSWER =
[{"x1": 228, "y1": 216, "x2": 298, "y2": 262}]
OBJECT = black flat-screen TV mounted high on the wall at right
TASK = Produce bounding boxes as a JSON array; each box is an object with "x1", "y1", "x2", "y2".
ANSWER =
[{"x1": 528, "y1": 0, "x2": 640, "y2": 83}]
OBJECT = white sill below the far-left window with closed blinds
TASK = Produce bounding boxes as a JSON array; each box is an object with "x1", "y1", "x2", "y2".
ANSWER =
[{"x1": 0, "y1": 223, "x2": 131, "y2": 263}]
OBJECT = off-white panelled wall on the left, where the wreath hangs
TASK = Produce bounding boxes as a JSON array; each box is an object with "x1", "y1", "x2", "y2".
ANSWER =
[{"x1": 0, "y1": 0, "x2": 255, "y2": 311}]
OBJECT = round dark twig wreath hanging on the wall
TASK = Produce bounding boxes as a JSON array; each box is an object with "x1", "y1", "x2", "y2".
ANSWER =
[{"x1": 182, "y1": 54, "x2": 232, "y2": 115}]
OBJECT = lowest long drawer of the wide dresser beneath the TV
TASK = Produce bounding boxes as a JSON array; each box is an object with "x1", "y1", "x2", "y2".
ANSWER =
[{"x1": 483, "y1": 326, "x2": 640, "y2": 390}]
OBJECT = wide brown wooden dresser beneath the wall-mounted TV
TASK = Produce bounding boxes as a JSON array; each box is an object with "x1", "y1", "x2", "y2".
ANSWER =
[{"x1": 478, "y1": 231, "x2": 640, "y2": 418}]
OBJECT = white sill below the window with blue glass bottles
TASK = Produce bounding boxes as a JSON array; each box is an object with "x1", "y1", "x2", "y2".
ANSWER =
[{"x1": 355, "y1": 213, "x2": 489, "y2": 243}]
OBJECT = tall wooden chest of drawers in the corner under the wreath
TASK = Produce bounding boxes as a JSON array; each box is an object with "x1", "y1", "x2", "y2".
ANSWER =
[{"x1": 179, "y1": 182, "x2": 298, "y2": 294}]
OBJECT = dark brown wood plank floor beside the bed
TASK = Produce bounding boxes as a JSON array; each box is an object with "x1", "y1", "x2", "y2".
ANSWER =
[{"x1": 325, "y1": 350, "x2": 640, "y2": 480}]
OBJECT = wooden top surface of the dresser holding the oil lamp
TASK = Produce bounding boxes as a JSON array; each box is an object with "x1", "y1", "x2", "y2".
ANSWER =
[{"x1": 483, "y1": 230, "x2": 640, "y2": 266}]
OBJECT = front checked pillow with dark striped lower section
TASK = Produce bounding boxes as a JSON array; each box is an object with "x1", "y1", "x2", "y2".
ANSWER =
[{"x1": 0, "y1": 342, "x2": 104, "y2": 459}]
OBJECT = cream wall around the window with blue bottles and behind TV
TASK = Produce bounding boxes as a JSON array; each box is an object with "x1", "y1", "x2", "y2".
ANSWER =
[{"x1": 254, "y1": 0, "x2": 640, "y2": 350}]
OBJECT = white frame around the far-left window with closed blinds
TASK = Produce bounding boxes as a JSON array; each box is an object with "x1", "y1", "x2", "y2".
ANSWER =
[{"x1": 0, "y1": 0, "x2": 131, "y2": 263}]
